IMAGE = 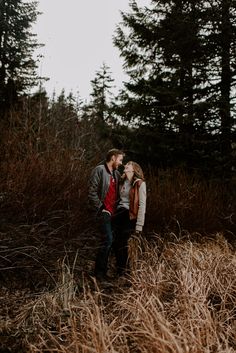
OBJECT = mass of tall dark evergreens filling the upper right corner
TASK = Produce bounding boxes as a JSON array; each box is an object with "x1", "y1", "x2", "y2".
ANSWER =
[{"x1": 114, "y1": 0, "x2": 236, "y2": 172}]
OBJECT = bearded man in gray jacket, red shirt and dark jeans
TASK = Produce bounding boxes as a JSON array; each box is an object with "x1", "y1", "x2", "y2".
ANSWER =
[{"x1": 88, "y1": 149, "x2": 124, "y2": 281}]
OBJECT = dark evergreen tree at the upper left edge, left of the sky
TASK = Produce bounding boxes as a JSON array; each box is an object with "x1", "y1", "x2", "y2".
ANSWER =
[{"x1": 0, "y1": 0, "x2": 39, "y2": 110}]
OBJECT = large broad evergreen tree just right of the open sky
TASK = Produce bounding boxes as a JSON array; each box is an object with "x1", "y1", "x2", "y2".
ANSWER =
[{"x1": 114, "y1": 0, "x2": 204, "y2": 132}]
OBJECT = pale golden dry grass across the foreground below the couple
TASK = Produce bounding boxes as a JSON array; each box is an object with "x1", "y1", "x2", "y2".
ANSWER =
[{"x1": 2, "y1": 234, "x2": 236, "y2": 353}]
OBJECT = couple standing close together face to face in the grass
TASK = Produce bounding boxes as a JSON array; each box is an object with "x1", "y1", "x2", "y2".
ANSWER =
[{"x1": 88, "y1": 149, "x2": 146, "y2": 281}]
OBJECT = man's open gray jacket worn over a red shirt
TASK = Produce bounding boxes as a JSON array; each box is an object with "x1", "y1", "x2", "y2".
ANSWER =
[{"x1": 88, "y1": 163, "x2": 120, "y2": 213}]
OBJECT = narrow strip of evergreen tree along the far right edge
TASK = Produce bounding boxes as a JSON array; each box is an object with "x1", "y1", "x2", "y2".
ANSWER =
[{"x1": 203, "y1": 0, "x2": 236, "y2": 162}]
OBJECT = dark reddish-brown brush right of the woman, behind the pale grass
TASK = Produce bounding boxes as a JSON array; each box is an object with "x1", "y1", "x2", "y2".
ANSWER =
[{"x1": 146, "y1": 169, "x2": 236, "y2": 236}]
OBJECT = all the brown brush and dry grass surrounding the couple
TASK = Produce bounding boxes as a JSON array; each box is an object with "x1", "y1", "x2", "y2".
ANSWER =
[{"x1": 0, "y1": 103, "x2": 236, "y2": 353}]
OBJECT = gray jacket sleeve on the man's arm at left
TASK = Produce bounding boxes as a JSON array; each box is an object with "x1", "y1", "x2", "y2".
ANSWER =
[{"x1": 88, "y1": 167, "x2": 103, "y2": 211}]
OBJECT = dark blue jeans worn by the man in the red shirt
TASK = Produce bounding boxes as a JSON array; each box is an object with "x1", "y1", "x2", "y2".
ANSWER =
[{"x1": 95, "y1": 212, "x2": 113, "y2": 277}]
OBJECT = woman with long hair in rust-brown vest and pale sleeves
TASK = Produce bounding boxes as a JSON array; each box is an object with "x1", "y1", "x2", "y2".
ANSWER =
[{"x1": 114, "y1": 161, "x2": 146, "y2": 275}]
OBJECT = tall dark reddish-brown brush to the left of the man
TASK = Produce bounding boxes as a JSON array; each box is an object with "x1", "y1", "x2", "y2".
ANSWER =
[{"x1": 0, "y1": 99, "x2": 100, "y2": 290}]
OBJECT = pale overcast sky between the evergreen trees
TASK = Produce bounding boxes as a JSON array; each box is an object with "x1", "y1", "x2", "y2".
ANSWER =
[{"x1": 33, "y1": 0, "x2": 150, "y2": 99}]
